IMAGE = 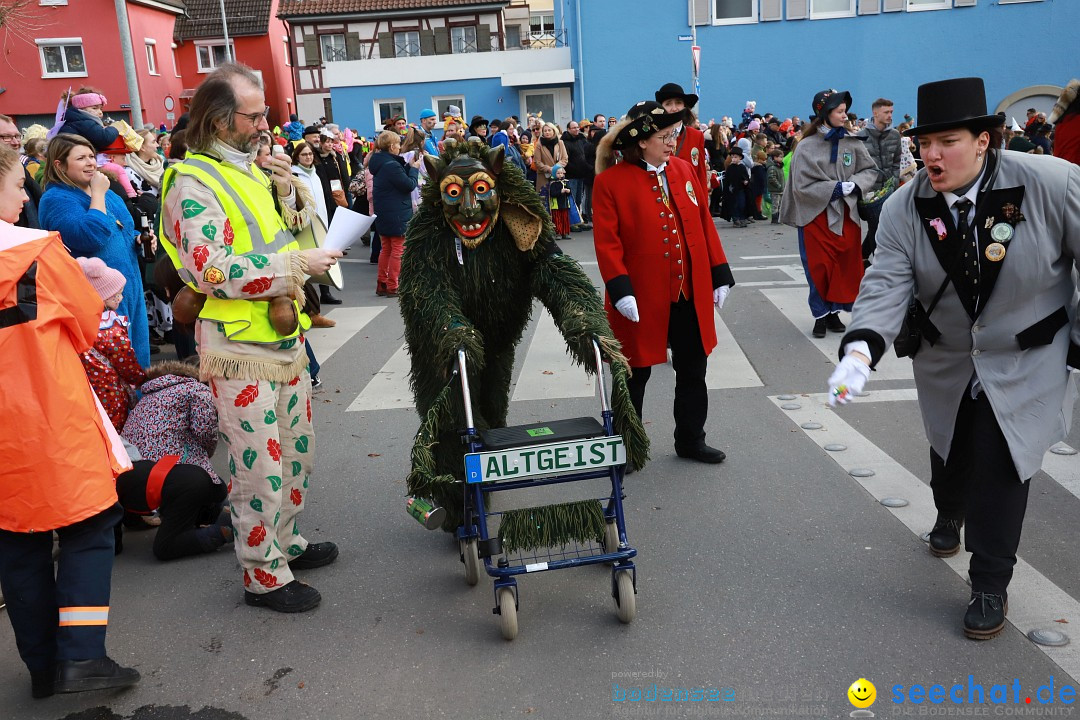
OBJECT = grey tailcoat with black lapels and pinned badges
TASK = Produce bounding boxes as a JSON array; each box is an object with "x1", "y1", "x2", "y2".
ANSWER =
[{"x1": 840, "y1": 150, "x2": 1080, "y2": 480}]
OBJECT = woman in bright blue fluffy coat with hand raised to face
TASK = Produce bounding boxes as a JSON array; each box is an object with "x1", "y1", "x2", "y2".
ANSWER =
[{"x1": 38, "y1": 135, "x2": 150, "y2": 368}]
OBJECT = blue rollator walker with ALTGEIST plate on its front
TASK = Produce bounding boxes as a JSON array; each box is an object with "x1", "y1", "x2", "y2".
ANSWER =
[{"x1": 457, "y1": 339, "x2": 637, "y2": 640}]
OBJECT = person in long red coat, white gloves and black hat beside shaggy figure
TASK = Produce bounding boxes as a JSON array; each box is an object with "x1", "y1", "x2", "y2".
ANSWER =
[{"x1": 593, "y1": 100, "x2": 734, "y2": 463}]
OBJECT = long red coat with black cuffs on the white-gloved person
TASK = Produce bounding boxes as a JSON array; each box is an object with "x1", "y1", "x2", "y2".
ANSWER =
[{"x1": 593, "y1": 158, "x2": 734, "y2": 367}]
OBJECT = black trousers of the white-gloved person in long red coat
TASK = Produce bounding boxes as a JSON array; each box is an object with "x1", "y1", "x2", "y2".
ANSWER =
[{"x1": 626, "y1": 298, "x2": 708, "y2": 448}]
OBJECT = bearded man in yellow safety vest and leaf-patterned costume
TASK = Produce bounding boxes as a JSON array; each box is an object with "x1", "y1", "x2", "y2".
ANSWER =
[{"x1": 161, "y1": 64, "x2": 341, "y2": 612}]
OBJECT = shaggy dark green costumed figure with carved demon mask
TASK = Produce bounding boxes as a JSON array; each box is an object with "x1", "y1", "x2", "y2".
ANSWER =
[{"x1": 399, "y1": 141, "x2": 649, "y2": 531}]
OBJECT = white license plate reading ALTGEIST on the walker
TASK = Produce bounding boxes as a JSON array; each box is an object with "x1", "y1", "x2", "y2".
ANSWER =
[{"x1": 465, "y1": 435, "x2": 626, "y2": 483}]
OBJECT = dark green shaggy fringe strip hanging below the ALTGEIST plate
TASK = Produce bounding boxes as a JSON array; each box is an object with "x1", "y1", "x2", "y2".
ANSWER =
[{"x1": 499, "y1": 500, "x2": 604, "y2": 554}]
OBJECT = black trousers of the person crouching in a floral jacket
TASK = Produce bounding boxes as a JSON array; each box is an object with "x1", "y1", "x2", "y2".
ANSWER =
[{"x1": 117, "y1": 460, "x2": 228, "y2": 560}]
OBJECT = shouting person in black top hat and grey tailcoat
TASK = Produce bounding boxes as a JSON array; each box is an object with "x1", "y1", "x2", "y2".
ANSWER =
[{"x1": 825, "y1": 78, "x2": 1080, "y2": 640}]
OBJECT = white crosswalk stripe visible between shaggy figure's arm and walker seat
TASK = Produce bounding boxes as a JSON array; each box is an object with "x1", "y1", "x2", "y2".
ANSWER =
[{"x1": 511, "y1": 307, "x2": 596, "y2": 402}]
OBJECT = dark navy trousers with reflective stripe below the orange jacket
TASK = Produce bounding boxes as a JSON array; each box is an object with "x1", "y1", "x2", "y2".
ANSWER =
[{"x1": 0, "y1": 505, "x2": 123, "y2": 673}]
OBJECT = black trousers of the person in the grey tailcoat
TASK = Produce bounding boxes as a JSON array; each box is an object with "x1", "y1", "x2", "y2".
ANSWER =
[{"x1": 930, "y1": 391, "x2": 1031, "y2": 595}]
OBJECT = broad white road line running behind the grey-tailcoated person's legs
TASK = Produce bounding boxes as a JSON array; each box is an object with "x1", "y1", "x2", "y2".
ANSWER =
[{"x1": 770, "y1": 391, "x2": 1080, "y2": 677}]
